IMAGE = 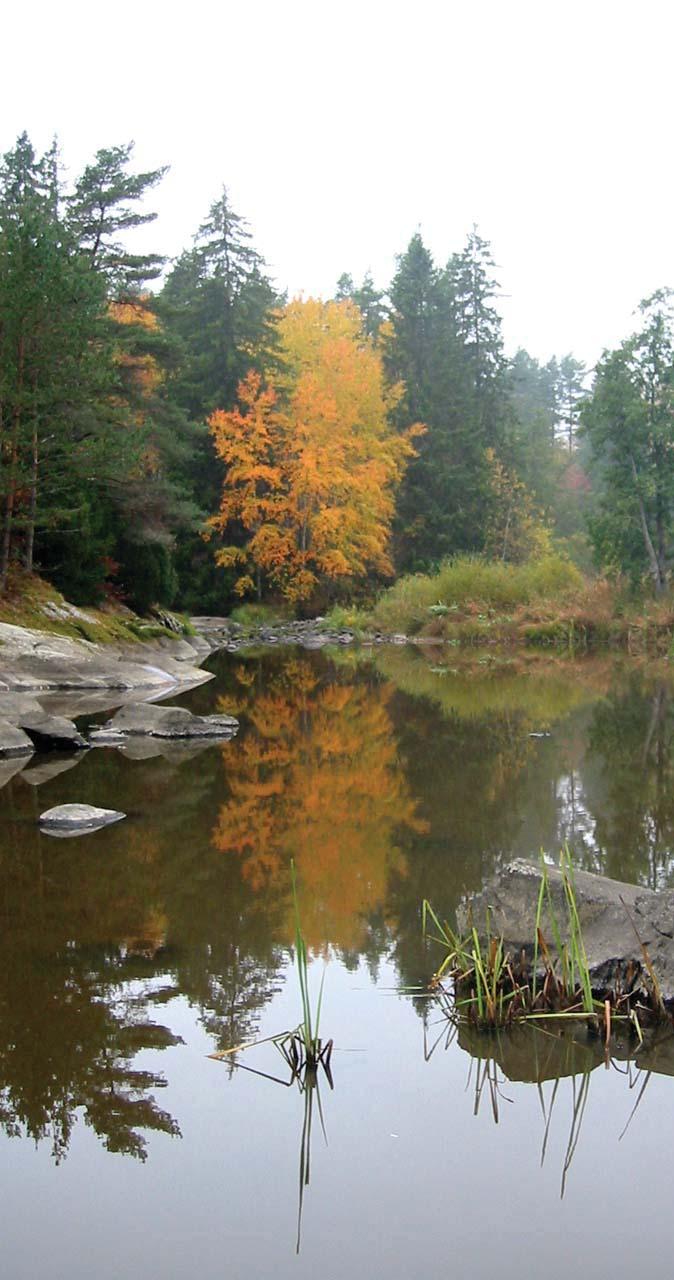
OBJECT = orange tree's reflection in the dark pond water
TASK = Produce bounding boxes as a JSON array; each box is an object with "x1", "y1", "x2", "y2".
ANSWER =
[{"x1": 214, "y1": 659, "x2": 425, "y2": 950}]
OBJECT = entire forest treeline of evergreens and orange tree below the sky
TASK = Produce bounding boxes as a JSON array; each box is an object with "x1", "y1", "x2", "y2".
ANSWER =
[{"x1": 0, "y1": 134, "x2": 674, "y2": 612}]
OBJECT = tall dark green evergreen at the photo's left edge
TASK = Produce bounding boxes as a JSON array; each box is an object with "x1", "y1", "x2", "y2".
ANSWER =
[{"x1": 0, "y1": 134, "x2": 116, "y2": 589}]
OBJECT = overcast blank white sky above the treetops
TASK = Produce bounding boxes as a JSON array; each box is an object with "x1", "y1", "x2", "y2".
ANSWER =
[{"x1": 5, "y1": 0, "x2": 674, "y2": 362}]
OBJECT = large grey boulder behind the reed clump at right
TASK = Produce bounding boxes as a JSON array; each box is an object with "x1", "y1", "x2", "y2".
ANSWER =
[{"x1": 457, "y1": 859, "x2": 674, "y2": 1004}]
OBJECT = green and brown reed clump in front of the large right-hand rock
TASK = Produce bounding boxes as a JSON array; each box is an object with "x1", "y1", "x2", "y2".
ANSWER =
[{"x1": 422, "y1": 849, "x2": 671, "y2": 1044}]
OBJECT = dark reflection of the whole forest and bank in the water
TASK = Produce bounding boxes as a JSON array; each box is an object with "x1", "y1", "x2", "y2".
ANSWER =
[{"x1": 0, "y1": 649, "x2": 674, "y2": 1160}]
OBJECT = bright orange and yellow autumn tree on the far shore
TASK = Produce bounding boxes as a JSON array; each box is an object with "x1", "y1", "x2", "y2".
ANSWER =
[{"x1": 208, "y1": 298, "x2": 422, "y2": 602}]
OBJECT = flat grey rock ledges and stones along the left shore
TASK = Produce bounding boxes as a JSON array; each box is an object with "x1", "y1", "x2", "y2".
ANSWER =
[{"x1": 0, "y1": 607, "x2": 407, "y2": 786}]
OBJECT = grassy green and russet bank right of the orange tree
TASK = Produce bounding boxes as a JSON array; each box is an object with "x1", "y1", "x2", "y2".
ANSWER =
[{"x1": 327, "y1": 556, "x2": 674, "y2": 653}]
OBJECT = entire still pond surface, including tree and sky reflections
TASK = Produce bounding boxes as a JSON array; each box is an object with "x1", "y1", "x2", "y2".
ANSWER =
[{"x1": 0, "y1": 650, "x2": 674, "y2": 1280}]
